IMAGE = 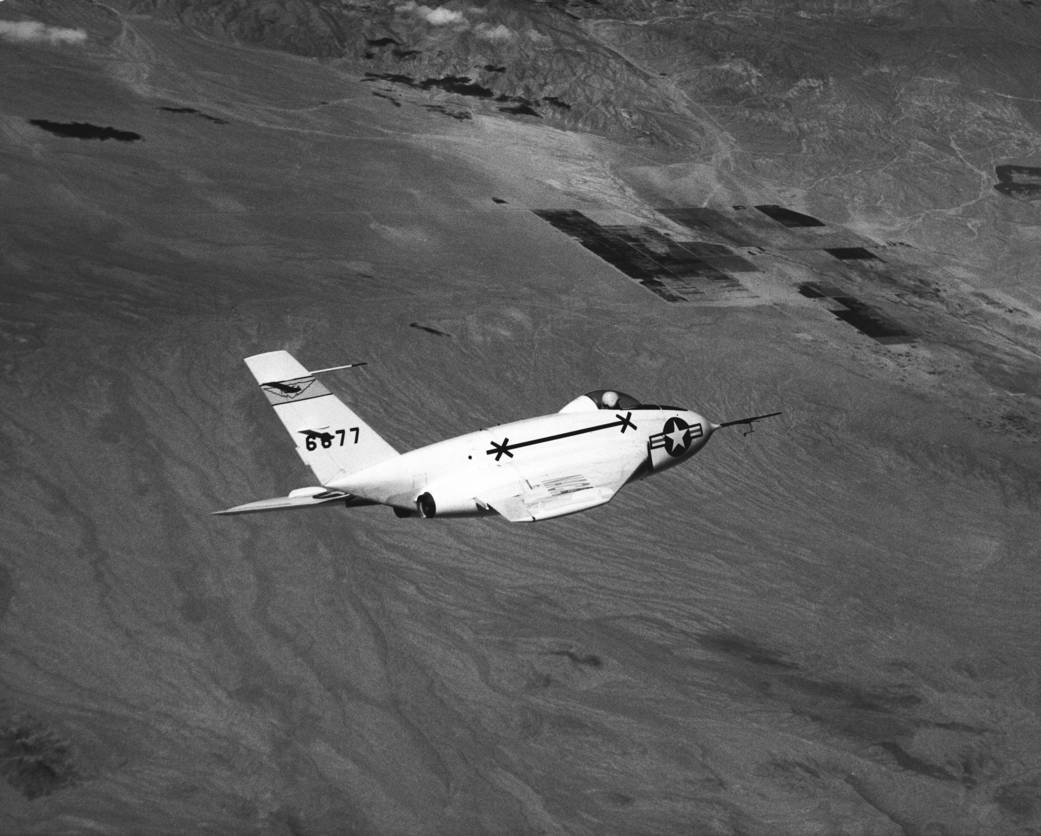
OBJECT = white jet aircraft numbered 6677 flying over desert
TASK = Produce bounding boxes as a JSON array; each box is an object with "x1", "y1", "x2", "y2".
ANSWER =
[{"x1": 215, "y1": 351, "x2": 781, "y2": 523}]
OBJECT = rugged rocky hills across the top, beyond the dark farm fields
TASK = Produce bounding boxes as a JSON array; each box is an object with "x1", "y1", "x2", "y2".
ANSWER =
[{"x1": 111, "y1": 0, "x2": 1041, "y2": 274}]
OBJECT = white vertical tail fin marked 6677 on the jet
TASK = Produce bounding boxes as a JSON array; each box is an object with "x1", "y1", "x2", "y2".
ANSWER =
[{"x1": 246, "y1": 351, "x2": 399, "y2": 485}]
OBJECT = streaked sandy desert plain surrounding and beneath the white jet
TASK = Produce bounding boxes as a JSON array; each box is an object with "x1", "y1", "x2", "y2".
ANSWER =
[{"x1": 0, "y1": 8, "x2": 1041, "y2": 834}]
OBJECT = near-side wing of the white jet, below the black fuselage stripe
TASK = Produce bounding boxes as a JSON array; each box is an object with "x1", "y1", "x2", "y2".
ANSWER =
[{"x1": 476, "y1": 458, "x2": 642, "y2": 523}]
